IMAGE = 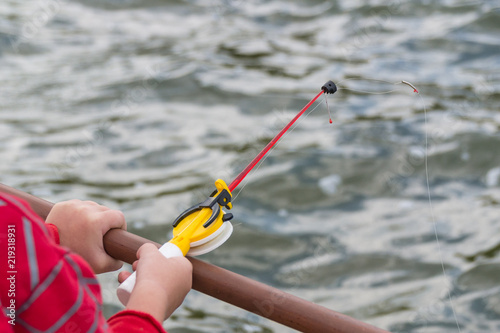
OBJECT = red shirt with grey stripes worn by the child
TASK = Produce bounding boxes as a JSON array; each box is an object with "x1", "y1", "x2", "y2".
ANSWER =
[{"x1": 0, "y1": 193, "x2": 165, "y2": 333}]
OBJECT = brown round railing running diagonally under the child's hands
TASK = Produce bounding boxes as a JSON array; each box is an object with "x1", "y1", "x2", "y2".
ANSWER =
[{"x1": 0, "y1": 184, "x2": 388, "y2": 333}]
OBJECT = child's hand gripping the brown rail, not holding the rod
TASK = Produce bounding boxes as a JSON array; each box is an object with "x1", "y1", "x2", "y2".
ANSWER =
[{"x1": 46, "y1": 200, "x2": 127, "y2": 274}]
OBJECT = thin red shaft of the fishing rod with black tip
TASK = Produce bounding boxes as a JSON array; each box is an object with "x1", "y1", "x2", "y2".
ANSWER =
[{"x1": 228, "y1": 81, "x2": 337, "y2": 192}]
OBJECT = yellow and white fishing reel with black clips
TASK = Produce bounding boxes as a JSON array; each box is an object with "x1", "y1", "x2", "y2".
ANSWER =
[{"x1": 170, "y1": 179, "x2": 233, "y2": 257}]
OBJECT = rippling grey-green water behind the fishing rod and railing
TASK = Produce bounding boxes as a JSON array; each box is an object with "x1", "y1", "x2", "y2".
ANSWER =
[{"x1": 0, "y1": 0, "x2": 500, "y2": 333}]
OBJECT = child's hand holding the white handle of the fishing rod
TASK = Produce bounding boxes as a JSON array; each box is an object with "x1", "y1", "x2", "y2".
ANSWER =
[{"x1": 118, "y1": 243, "x2": 193, "y2": 322}]
